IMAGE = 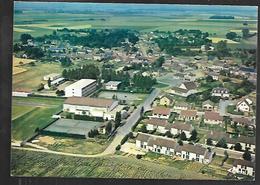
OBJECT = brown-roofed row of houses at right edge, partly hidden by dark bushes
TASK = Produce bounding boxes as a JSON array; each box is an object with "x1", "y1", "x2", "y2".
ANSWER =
[{"x1": 205, "y1": 131, "x2": 256, "y2": 153}]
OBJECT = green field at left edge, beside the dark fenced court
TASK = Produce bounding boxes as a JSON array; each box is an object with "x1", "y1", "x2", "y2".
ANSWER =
[{"x1": 11, "y1": 97, "x2": 63, "y2": 141}]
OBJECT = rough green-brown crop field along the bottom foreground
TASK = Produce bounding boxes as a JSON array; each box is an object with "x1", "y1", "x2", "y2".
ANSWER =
[{"x1": 11, "y1": 149, "x2": 215, "y2": 179}]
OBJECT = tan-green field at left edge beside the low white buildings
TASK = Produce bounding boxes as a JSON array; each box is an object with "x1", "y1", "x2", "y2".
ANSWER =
[{"x1": 13, "y1": 62, "x2": 62, "y2": 90}]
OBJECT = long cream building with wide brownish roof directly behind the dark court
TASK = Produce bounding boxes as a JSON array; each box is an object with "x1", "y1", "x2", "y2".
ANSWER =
[{"x1": 63, "y1": 97, "x2": 118, "y2": 120}]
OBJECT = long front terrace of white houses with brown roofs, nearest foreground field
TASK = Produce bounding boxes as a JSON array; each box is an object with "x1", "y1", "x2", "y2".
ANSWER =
[{"x1": 136, "y1": 133, "x2": 213, "y2": 164}]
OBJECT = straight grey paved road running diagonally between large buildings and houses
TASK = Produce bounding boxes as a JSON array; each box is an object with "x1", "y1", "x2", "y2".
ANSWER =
[{"x1": 101, "y1": 89, "x2": 160, "y2": 155}]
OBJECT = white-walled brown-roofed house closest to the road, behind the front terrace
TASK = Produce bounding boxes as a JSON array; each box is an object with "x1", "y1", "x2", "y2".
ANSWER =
[{"x1": 145, "y1": 118, "x2": 168, "y2": 134}]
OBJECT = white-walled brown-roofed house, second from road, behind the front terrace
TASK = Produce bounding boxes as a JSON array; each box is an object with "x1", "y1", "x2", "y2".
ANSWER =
[{"x1": 166, "y1": 122, "x2": 193, "y2": 138}]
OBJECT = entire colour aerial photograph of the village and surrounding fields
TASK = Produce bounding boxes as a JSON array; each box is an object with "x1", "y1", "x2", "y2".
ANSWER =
[{"x1": 10, "y1": 1, "x2": 258, "y2": 181}]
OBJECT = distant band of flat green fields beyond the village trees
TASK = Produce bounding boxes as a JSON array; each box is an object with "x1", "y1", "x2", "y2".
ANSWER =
[{"x1": 14, "y1": 11, "x2": 257, "y2": 43}]
